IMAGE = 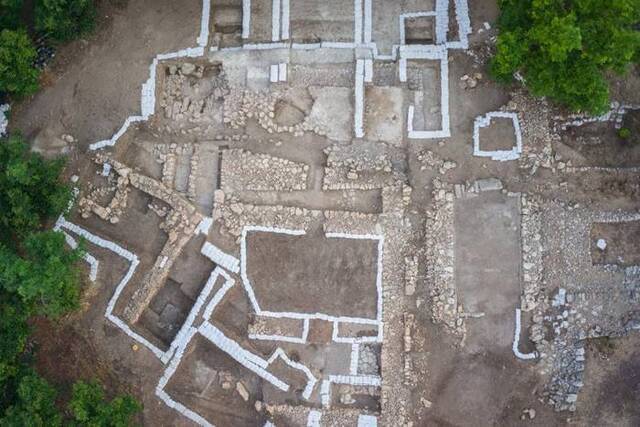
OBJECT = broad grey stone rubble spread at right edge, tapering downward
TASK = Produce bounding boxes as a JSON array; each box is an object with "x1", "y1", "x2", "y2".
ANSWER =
[{"x1": 523, "y1": 204, "x2": 640, "y2": 412}]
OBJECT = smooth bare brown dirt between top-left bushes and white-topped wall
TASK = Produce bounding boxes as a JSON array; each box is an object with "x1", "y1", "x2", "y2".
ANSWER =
[{"x1": 11, "y1": 0, "x2": 201, "y2": 154}]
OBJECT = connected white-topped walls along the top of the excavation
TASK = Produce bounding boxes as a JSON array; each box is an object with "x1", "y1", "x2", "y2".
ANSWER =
[{"x1": 90, "y1": 0, "x2": 471, "y2": 150}]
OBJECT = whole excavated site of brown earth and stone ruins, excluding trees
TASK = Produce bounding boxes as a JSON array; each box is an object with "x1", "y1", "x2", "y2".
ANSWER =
[{"x1": 11, "y1": 0, "x2": 640, "y2": 427}]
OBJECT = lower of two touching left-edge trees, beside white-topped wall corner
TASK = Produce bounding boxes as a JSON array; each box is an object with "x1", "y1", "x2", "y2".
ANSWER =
[{"x1": 0, "y1": 231, "x2": 82, "y2": 318}]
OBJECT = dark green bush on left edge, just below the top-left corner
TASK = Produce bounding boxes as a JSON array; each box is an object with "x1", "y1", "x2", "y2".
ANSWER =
[{"x1": 0, "y1": 30, "x2": 40, "y2": 97}]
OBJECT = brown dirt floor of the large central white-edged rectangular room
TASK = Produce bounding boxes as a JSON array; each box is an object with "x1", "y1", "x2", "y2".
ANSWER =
[{"x1": 242, "y1": 232, "x2": 379, "y2": 319}]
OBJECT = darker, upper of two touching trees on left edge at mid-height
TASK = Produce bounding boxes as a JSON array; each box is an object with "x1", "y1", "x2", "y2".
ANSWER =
[{"x1": 0, "y1": 135, "x2": 71, "y2": 244}]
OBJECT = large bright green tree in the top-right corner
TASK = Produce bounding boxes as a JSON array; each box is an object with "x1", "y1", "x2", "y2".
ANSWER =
[{"x1": 491, "y1": 0, "x2": 640, "y2": 114}]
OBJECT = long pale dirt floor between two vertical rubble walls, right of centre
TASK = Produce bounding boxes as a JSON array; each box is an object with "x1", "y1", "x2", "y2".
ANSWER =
[{"x1": 455, "y1": 192, "x2": 522, "y2": 352}]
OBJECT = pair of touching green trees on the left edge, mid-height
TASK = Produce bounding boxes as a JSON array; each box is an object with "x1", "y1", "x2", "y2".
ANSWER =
[{"x1": 0, "y1": 135, "x2": 82, "y2": 317}]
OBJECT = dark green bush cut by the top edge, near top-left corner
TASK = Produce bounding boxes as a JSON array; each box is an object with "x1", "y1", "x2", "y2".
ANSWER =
[{"x1": 36, "y1": 0, "x2": 96, "y2": 41}]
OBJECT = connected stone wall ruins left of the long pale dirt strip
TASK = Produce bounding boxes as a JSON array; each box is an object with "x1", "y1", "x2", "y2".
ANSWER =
[{"x1": 75, "y1": 0, "x2": 470, "y2": 427}]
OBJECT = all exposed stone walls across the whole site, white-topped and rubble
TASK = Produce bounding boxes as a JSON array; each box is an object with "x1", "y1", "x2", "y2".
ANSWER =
[{"x1": 58, "y1": 0, "x2": 640, "y2": 427}]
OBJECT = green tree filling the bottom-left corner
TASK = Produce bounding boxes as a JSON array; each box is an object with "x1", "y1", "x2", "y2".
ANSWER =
[{"x1": 0, "y1": 372, "x2": 62, "y2": 427}]
